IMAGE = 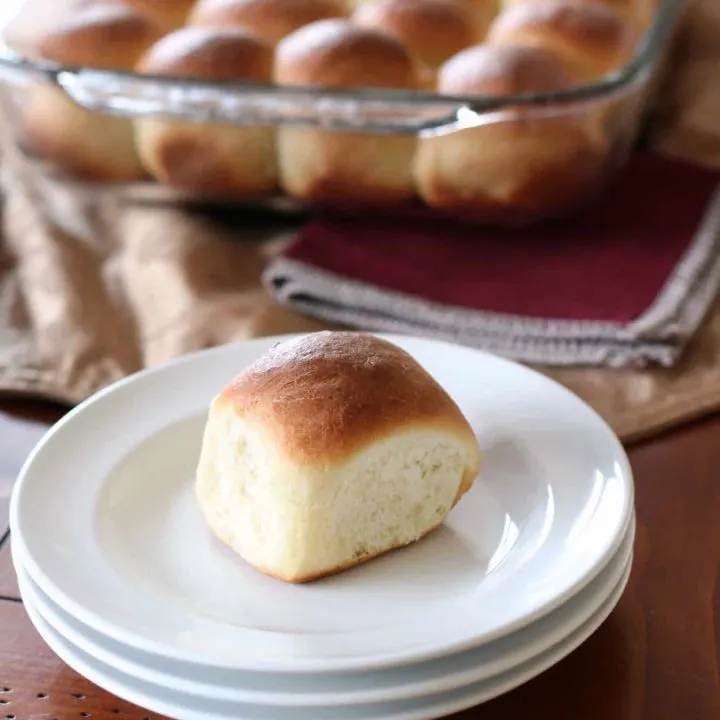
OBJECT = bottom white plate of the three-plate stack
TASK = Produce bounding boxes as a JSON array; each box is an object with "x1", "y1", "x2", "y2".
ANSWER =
[{"x1": 25, "y1": 560, "x2": 632, "y2": 720}]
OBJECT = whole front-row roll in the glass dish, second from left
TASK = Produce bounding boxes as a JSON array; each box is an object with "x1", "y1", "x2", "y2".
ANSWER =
[{"x1": 135, "y1": 27, "x2": 277, "y2": 198}]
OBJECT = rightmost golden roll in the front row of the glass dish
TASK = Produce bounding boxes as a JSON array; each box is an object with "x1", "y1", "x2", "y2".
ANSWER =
[{"x1": 415, "y1": 45, "x2": 603, "y2": 215}]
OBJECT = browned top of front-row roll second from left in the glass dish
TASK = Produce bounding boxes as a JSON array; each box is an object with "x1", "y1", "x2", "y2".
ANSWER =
[{"x1": 137, "y1": 27, "x2": 273, "y2": 82}]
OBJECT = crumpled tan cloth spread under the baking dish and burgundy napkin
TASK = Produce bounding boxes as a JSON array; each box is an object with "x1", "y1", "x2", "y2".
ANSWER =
[{"x1": 0, "y1": 0, "x2": 720, "y2": 442}]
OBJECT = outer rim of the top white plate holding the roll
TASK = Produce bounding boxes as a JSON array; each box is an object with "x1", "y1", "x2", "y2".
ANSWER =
[{"x1": 9, "y1": 331, "x2": 635, "y2": 673}]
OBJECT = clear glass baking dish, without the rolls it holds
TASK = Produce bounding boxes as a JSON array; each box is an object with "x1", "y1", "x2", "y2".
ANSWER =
[{"x1": 0, "y1": 0, "x2": 684, "y2": 224}]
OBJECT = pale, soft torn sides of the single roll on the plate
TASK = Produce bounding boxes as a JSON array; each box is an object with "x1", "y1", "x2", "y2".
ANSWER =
[{"x1": 196, "y1": 420, "x2": 476, "y2": 583}]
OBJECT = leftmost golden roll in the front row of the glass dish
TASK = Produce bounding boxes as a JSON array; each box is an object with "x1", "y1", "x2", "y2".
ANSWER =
[{"x1": 23, "y1": 4, "x2": 162, "y2": 181}]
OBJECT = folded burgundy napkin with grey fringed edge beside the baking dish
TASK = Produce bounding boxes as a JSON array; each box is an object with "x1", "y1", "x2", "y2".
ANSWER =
[{"x1": 264, "y1": 155, "x2": 720, "y2": 367}]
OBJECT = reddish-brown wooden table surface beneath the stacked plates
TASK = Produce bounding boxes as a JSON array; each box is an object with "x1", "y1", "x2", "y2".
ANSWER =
[{"x1": 0, "y1": 402, "x2": 720, "y2": 720}]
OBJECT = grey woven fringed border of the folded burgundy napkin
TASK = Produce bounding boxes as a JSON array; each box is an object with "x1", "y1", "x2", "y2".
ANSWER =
[{"x1": 263, "y1": 185, "x2": 720, "y2": 367}]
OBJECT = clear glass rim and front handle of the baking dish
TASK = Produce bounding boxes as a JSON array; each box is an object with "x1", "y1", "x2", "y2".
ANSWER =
[{"x1": 0, "y1": 0, "x2": 685, "y2": 137}]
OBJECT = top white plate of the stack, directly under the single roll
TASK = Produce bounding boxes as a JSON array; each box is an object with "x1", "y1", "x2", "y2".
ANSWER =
[{"x1": 11, "y1": 336, "x2": 633, "y2": 672}]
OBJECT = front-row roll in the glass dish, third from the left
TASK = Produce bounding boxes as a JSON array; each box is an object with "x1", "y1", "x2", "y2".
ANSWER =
[{"x1": 275, "y1": 20, "x2": 421, "y2": 204}]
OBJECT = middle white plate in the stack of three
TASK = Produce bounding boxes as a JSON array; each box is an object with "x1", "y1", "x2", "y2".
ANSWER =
[{"x1": 13, "y1": 521, "x2": 635, "y2": 707}]
